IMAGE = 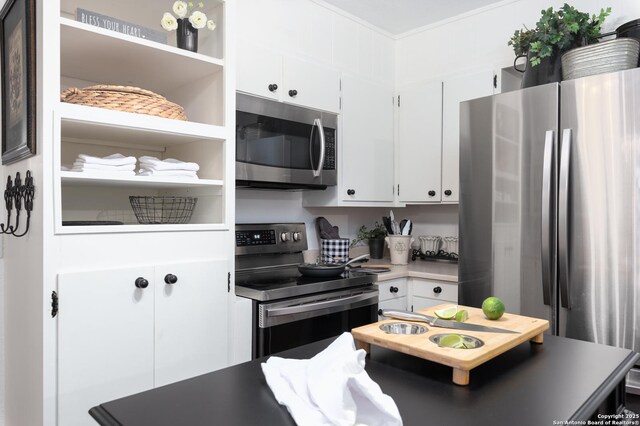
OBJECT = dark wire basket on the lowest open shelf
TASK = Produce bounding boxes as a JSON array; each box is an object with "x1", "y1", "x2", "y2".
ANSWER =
[{"x1": 129, "y1": 195, "x2": 198, "y2": 224}]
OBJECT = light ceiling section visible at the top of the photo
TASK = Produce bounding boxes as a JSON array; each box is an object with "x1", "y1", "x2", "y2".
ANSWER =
[{"x1": 324, "y1": 0, "x2": 498, "y2": 35}]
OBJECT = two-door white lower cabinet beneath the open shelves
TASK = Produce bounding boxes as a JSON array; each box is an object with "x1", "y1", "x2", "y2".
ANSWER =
[{"x1": 58, "y1": 259, "x2": 228, "y2": 426}]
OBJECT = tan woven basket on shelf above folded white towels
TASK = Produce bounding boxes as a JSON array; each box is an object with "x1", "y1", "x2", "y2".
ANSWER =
[{"x1": 60, "y1": 85, "x2": 187, "y2": 121}]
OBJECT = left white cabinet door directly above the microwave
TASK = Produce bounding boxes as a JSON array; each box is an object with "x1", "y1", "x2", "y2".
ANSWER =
[{"x1": 236, "y1": 43, "x2": 282, "y2": 100}]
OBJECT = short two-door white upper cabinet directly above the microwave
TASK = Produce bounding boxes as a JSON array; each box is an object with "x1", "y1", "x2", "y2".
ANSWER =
[{"x1": 236, "y1": 43, "x2": 340, "y2": 112}]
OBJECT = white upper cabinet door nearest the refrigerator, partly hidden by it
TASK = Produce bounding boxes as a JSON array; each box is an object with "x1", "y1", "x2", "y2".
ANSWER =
[{"x1": 442, "y1": 70, "x2": 493, "y2": 203}]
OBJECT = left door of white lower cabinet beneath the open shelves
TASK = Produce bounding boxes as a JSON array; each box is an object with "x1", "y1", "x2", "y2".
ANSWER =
[{"x1": 57, "y1": 267, "x2": 154, "y2": 426}]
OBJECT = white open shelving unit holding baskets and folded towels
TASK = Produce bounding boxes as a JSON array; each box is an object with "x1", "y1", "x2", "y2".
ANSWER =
[{"x1": 54, "y1": 0, "x2": 233, "y2": 234}]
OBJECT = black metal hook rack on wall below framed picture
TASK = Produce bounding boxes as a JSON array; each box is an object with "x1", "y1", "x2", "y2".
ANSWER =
[{"x1": 0, "y1": 170, "x2": 35, "y2": 237}]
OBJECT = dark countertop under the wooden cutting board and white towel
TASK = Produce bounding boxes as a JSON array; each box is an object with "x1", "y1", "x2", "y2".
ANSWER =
[{"x1": 91, "y1": 335, "x2": 640, "y2": 426}]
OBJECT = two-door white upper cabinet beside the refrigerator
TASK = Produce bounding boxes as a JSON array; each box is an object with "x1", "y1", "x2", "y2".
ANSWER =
[{"x1": 396, "y1": 70, "x2": 494, "y2": 204}]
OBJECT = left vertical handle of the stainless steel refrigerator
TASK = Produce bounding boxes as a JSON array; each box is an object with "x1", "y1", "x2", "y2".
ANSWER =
[{"x1": 540, "y1": 130, "x2": 555, "y2": 306}]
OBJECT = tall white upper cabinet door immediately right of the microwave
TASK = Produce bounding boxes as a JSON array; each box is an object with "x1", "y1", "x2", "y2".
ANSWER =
[{"x1": 338, "y1": 76, "x2": 393, "y2": 201}]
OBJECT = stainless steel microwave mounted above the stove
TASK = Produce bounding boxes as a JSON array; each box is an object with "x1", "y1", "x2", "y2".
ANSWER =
[{"x1": 236, "y1": 93, "x2": 338, "y2": 189}]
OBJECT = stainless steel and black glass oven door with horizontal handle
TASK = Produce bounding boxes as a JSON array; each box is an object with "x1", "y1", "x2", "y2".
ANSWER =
[{"x1": 252, "y1": 286, "x2": 378, "y2": 359}]
